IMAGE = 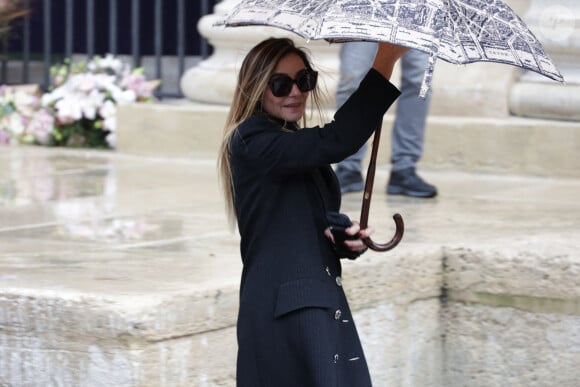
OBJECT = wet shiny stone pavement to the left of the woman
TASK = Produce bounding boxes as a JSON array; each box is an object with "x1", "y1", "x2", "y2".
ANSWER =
[{"x1": 0, "y1": 148, "x2": 239, "y2": 297}]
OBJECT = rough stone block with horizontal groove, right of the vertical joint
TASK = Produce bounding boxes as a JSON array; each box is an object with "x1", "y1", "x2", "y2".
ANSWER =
[{"x1": 441, "y1": 241, "x2": 580, "y2": 387}]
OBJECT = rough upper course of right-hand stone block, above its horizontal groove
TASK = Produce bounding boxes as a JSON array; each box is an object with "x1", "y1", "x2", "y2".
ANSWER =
[{"x1": 445, "y1": 238, "x2": 580, "y2": 302}]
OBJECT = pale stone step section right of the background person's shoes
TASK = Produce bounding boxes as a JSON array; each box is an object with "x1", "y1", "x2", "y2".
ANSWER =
[{"x1": 422, "y1": 116, "x2": 580, "y2": 178}]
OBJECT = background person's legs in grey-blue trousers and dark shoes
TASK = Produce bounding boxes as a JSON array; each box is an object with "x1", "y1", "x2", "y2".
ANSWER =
[{"x1": 336, "y1": 42, "x2": 437, "y2": 198}]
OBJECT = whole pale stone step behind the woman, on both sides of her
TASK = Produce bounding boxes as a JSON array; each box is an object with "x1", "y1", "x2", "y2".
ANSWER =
[{"x1": 117, "y1": 100, "x2": 580, "y2": 178}]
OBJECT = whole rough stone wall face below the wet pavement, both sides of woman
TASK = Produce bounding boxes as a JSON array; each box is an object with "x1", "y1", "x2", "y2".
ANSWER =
[{"x1": 0, "y1": 236, "x2": 580, "y2": 387}]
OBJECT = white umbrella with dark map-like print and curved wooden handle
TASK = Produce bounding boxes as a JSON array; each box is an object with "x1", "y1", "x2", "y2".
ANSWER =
[{"x1": 216, "y1": 0, "x2": 564, "y2": 251}]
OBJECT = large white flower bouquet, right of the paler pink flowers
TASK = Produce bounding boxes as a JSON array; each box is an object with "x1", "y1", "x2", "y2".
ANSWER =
[{"x1": 41, "y1": 55, "x2": 159, "y2": 148}]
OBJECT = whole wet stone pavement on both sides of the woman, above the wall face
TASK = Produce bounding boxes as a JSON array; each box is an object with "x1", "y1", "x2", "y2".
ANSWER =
[{"x1": 0, "y1": 147, "x2": 580, "y2": 297}]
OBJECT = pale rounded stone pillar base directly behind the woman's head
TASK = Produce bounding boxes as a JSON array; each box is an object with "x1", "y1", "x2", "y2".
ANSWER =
[{"x1": 180, "y1": 0, "x2": 339, "y2": 107}]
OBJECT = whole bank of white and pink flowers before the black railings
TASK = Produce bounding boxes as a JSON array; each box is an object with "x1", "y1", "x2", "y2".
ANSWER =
[{"x1": 0, "y1": 55, "x2": 159, "y2": 149}]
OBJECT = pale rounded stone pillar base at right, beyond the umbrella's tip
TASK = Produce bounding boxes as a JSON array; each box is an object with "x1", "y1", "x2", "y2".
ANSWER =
[{"x1": 510, "y1": 0, "x2": 580, "y2": 121}]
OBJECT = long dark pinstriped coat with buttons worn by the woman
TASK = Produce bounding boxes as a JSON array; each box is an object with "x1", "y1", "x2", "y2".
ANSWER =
[{"x1": 230, "y1": 70, "x2": 399, "y2": 387}]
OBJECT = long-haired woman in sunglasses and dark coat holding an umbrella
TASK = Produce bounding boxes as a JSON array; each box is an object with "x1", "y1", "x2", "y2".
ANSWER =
[{"x1": 220, "y1": 38, "x2": 406, "y2": 387}]
